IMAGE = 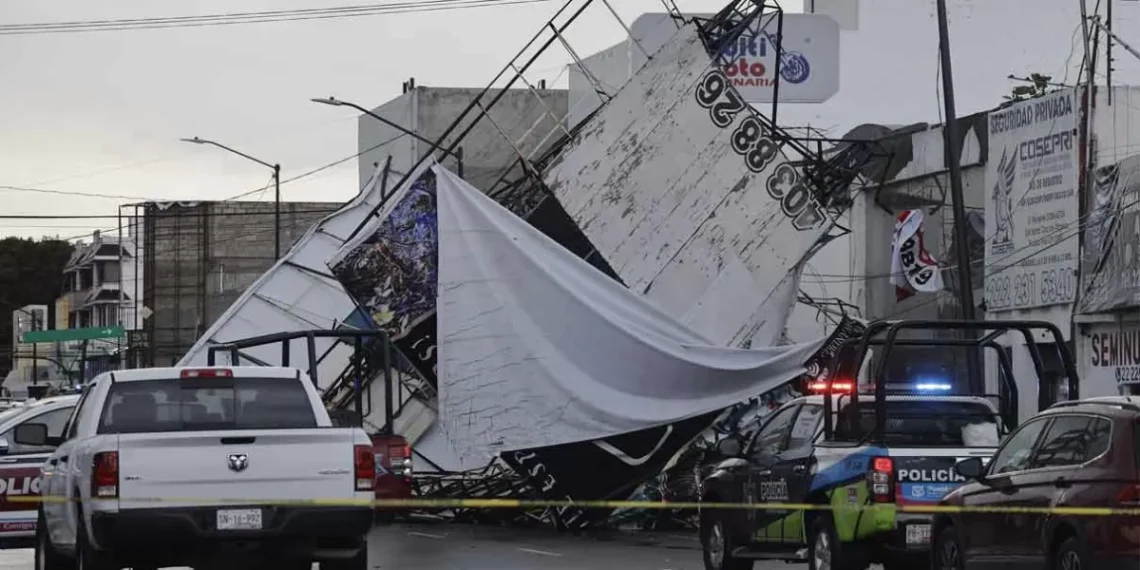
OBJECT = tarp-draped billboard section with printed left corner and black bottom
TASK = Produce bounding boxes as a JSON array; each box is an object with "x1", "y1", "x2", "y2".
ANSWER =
[{"x1": 328, "y1": 165, "x2": 820, "y2": 527}]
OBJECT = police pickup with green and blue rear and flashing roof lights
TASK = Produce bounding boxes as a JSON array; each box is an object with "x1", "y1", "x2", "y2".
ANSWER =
[{"x1": 700, "y1": 382, "x2": 1004, "y2": 570}]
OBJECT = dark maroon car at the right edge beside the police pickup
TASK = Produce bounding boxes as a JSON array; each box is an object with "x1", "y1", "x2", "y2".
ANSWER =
[{"x1": 931, "y1": 396, "x2": 1140, "y2": 570}]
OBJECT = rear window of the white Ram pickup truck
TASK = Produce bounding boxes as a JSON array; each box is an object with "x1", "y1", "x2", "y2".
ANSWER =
[{"x1": 99, "y1": 378, "x2": 317, "y2": 433}]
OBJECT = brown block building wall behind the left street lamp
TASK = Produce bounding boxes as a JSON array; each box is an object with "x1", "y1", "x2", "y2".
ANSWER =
[{"x1": 144, "y1": 202, "x2": 340, "y2": 366}]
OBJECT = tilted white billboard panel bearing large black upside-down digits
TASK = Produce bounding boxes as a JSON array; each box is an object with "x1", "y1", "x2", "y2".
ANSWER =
[{"x1": 544, "y1": 23, "x2": 831, "y2": 347}]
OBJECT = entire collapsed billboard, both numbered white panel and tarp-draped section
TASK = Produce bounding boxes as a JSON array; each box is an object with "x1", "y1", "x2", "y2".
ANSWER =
[{"x1": 328, "y1": 13, "x2": 831, "y2": 528}]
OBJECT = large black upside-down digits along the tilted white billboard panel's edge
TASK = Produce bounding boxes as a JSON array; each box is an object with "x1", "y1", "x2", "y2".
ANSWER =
[{"x1": 695, "y1": 70, "x2": 824, "y2": 231}]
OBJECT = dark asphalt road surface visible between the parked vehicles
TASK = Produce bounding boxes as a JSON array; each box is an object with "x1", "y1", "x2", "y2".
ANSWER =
[{"x1": 0, "y1": 523, "x2": 807, "y2": 570}]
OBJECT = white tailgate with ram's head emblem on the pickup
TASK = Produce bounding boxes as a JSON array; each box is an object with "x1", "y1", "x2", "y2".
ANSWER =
[{"x1": 119, "y1": 428, "x2": 355, "y2": 508}]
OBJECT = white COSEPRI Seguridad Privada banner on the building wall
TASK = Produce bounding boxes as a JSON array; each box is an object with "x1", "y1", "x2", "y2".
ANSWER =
[{"x1": 985, "y1": 89, "x2": 1081, "y2": 311}]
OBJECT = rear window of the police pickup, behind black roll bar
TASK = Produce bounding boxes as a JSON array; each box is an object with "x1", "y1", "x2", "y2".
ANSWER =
[{"x1": 836, "y1": 399, "x2": 1001, "y2": 447}]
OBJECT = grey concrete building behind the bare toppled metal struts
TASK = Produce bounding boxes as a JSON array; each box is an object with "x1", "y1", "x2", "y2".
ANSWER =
[{"x1": 357, "y1": 86, "x2": 568, "y2": 192}]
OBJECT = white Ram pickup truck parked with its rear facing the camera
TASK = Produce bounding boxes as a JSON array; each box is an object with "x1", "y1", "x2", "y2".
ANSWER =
[{"x1": 15, "y1": 367, "x2": 376, "y2": 570}]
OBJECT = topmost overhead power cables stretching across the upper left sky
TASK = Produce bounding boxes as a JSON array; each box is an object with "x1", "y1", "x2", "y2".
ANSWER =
[{"x1": 0, "y1": 0, "x2": 549, "y2": 35}]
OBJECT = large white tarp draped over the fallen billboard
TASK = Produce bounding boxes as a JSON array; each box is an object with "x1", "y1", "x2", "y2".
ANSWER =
[{"x1": 434, "y1": 165, "x2": 822, "y2": 456}]
